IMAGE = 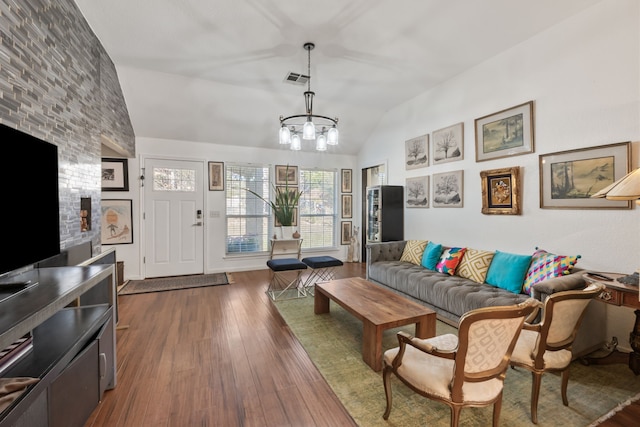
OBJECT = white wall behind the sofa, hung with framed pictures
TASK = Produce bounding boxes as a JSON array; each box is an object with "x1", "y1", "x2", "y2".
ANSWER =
[{"x1": 358, "y1": 0, "x2": 640, "y2": 347}]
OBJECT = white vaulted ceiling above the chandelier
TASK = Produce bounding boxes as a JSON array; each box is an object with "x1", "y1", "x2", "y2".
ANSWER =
[{"x1": 76, "y1": 0, "x2": 599, "y2": 154}]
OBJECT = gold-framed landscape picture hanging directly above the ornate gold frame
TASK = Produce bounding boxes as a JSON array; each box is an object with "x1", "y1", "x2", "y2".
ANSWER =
[{"x1": 475, "y1": 101, "x2": 534, "y2": 162}]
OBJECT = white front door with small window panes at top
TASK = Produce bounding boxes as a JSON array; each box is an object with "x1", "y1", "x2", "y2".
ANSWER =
[{"x1": 143, "y1": 158, "x2": 205, "y2": 277}]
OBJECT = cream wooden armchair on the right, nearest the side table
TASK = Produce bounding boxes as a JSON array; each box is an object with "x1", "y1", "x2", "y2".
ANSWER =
[{"x1": 511, "y1": 283, "x2": 604, "y2": 424}]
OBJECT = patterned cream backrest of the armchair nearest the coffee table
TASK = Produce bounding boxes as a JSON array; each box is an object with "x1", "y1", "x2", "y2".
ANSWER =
[{"x1": 451, "y1": 299, "x2": 537, "y2": 402}]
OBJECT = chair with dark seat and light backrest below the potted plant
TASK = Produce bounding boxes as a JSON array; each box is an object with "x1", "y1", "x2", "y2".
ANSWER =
[{"x1": 267, "y1": 239, "x2": 307, "y2": 301}]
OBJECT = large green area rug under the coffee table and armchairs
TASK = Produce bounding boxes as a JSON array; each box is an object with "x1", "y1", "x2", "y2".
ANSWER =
[{"x1": 275, "y1": 298, "x2": 640, "y2": 427}]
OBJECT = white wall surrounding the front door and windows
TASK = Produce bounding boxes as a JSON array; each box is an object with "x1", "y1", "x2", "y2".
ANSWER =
[{"x1": 112, "y1": 138, "x2": 359, "y2": 280}]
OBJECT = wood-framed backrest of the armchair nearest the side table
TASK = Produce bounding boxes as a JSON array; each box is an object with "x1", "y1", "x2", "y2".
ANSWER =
[{"x1": 533, "y1": 283, "x2": 605, "y2": 362}]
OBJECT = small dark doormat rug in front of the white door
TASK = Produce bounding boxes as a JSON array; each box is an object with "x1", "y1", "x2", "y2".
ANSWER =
[{"x1": 118, "y1": 273, "x2": 231, "y2": 295}]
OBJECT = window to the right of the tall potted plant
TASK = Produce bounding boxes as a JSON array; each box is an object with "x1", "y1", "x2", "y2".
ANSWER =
[{"x1": 299, "y1": 169, "x2": 338, "y2": 249}]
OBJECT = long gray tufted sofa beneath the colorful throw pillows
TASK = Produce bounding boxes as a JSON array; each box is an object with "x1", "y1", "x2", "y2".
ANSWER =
[{"x1": 366, "y1": 241, "x2": 604, "y2": 357}]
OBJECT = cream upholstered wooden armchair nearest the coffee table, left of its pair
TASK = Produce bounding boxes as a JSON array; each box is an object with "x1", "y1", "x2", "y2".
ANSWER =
[{"x1": 383, "y1": 299, "x2": 536, "y2": 426}]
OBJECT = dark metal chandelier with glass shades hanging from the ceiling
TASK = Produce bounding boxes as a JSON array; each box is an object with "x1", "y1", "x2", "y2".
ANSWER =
[{"x1": 279, "y1": 43, "x2": 338, "y2": 151}]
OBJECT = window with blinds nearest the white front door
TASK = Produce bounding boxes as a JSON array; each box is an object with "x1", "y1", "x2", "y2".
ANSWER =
[{"x1": 225, "y1": 164, "x2": 271, "y2": 254}]
